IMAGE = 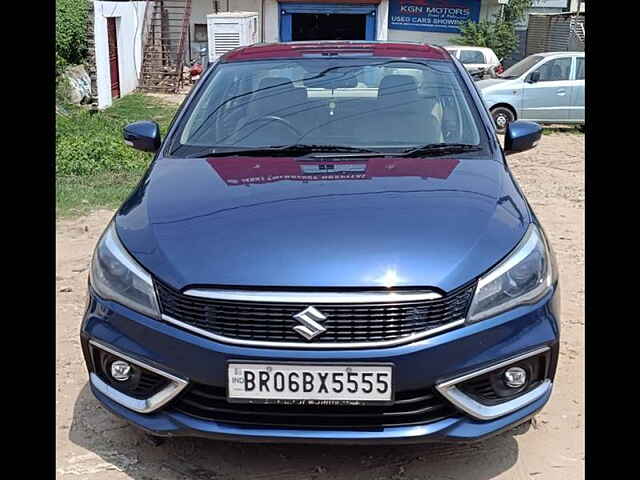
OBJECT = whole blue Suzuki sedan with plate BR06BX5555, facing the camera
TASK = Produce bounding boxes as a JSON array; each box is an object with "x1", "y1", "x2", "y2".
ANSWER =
[{"x1": 81, "y1": 42, "x2": 559, "y2": 443}]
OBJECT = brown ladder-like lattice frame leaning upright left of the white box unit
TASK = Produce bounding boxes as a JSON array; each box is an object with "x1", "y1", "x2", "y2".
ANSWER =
[{"x1": 138, "y1": 0, "x2": 191, "y2": 93}]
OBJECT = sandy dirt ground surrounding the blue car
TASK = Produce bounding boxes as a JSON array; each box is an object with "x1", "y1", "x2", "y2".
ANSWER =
[{"x1": 56, "y1": 133, "x2": 584, "y2": 480}]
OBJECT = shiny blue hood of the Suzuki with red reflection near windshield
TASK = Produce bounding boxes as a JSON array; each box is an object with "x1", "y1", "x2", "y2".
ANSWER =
[{"x1": 116, "y1": 157, "x2": 530, "y2": 292}]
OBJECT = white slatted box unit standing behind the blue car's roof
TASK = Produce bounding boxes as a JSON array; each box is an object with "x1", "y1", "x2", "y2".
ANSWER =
[{"x1": 207, "y1": 12, "x2": 258, "y2": 62}]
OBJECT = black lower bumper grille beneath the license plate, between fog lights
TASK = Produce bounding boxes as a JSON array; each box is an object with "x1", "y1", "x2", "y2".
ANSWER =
[{"x1": 171, "y1": 383, "x2": 456, "y2": 430}]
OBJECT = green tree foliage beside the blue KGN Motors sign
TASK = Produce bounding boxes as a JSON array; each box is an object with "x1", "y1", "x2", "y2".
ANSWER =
[{"x1": 454, "y1": 0, "x2": 532, "y2": 58}]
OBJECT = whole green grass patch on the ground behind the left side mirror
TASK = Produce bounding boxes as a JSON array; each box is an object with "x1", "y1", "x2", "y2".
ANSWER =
[{"x1": 56, "y1": 94, "x2": 178, "y2": 216}]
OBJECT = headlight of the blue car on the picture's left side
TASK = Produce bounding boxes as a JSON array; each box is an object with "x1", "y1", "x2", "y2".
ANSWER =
[{"x1": 90, "y1": 222, "x2": 160, "y2": 318}]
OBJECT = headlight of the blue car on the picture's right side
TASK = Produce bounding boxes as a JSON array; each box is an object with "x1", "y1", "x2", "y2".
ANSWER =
[{"x1": 467, "y1": 224, "x2": 555, "y2": 323}]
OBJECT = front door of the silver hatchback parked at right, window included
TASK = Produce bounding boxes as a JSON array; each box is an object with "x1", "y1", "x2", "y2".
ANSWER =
[{"x1": 520, "y1": 56, "x2": 573, "y2": 123}]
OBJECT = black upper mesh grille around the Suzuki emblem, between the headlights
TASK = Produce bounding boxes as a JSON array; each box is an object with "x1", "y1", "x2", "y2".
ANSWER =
[{"x1": 156, "y1": 282, "x2": 475, "y2": 344}]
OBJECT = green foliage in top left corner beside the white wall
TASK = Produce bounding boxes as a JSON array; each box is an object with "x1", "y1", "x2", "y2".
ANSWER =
[{"x1": 56, "y1": 0, "x2": 89, "y2": 75}]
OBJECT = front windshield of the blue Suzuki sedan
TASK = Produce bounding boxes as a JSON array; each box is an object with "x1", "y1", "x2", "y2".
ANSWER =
[{"x1": 168, "y1": 58, "x2": 486, "y2": 156}]
